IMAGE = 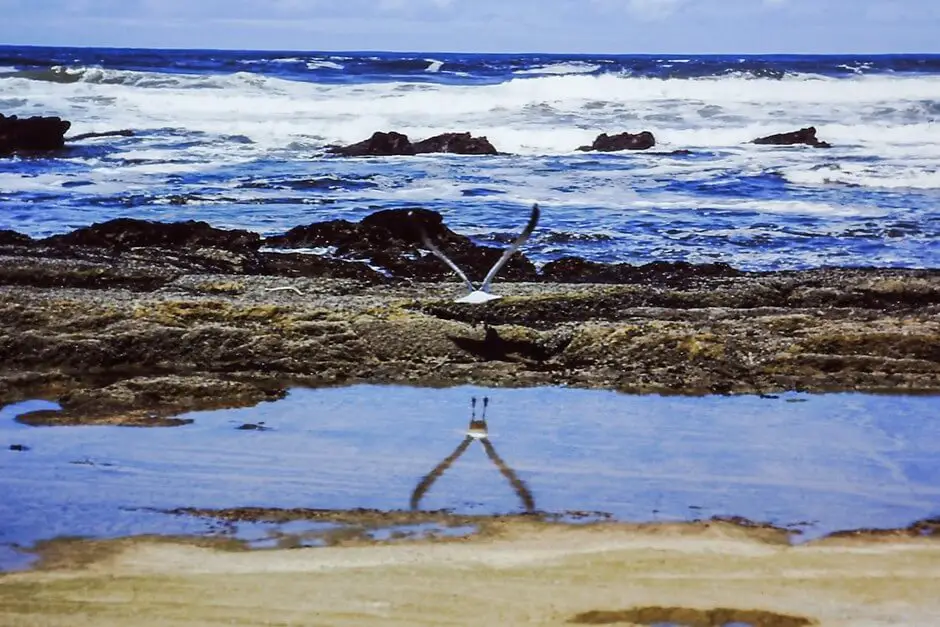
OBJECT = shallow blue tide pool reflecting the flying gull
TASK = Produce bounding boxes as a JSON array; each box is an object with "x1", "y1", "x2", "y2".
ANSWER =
[{"x1": 0, "y1": 385, "x2": 940, "y2": 568}]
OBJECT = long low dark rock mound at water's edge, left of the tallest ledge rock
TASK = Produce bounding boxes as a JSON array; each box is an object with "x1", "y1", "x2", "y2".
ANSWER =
[{"x1": 40, "y1": 218, "x2": 261, "y2": 252}]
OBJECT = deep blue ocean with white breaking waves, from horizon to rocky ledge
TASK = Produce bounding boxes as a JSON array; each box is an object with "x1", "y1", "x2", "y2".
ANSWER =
[{"x1": 0, "y1": 46, "x2": 940, "y2": 269}]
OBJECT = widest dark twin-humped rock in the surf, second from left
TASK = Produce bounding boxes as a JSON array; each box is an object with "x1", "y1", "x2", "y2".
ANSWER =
[{"x1": 327, "y1": 131, "x2": 497, "y2": 157}]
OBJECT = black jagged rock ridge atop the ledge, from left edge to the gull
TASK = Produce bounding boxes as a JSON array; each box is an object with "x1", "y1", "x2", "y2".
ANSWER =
[{"x1": 0, "y1": 209, "x2": 538, "y2": 289}]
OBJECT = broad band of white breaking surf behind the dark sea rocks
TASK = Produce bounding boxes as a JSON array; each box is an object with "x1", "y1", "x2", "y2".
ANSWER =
[{"x1": 9, "y1": 67, "x2": 940, "y2": 156}]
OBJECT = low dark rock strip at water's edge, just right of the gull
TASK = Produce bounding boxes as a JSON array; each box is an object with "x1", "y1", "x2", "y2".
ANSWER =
[{"x1": 541, "y1": 257, "x2": 742, "y2": 286}]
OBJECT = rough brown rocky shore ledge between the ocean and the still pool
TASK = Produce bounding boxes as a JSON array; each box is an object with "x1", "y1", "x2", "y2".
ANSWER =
[{"x1": 0, "y1": 212, "x2": 940, "y2": 425}]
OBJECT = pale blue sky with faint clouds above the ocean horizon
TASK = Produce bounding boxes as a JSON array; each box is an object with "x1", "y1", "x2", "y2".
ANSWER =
[{"x1": 0, "y1": 0, "x2": 940, "y2": 54}]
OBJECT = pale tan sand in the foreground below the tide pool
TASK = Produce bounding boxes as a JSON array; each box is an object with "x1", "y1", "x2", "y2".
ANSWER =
[{"x1": 0, "y1": 522, "x2": 940, "y2": 627}]
